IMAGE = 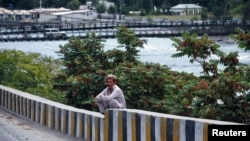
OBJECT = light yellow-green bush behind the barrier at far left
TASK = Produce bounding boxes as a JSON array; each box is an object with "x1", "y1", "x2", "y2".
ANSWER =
[{"x1": 0, "y1": 50, "x2": 64, "y2": 103}]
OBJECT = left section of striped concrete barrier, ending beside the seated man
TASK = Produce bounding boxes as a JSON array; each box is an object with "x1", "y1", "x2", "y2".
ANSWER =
[{"x1": 0, "y1": 85, "x2": 104, "y2": 141}]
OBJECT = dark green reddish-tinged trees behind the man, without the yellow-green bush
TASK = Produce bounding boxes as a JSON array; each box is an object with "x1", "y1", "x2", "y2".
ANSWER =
[{"x1": 53, "y1": 26, "x2": 250, "y2": 122}]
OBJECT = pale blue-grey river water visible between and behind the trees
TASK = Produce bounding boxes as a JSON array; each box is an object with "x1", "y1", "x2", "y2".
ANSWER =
[{"x1": 0, "y1": 38, "x2": 250, "y2": 76}]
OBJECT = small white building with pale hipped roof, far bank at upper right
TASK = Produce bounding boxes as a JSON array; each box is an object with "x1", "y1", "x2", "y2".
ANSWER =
[{"x1": 169, "y1": 4, "x2": 202, "y2": 15}]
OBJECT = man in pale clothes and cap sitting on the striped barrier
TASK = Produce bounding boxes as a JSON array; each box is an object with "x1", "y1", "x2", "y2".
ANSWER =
[{"x1": 95, "y1": 74, "x2": 126, "y2": 114}]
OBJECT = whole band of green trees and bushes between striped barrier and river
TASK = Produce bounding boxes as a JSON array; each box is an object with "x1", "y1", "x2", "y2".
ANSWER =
[{"x1": 0, "y1": 26, "x2": 250, "y2": 122}]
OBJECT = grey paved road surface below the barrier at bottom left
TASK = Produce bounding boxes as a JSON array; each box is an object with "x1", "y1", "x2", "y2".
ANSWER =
[{"x1": 0, "y1": 109, "x2": 80, "y2": 141}]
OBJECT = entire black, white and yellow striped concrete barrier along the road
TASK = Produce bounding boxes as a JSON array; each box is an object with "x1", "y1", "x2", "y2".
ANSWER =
[{"x1": 0, "y1": 85, "x2": 242, "y2": 141}]
